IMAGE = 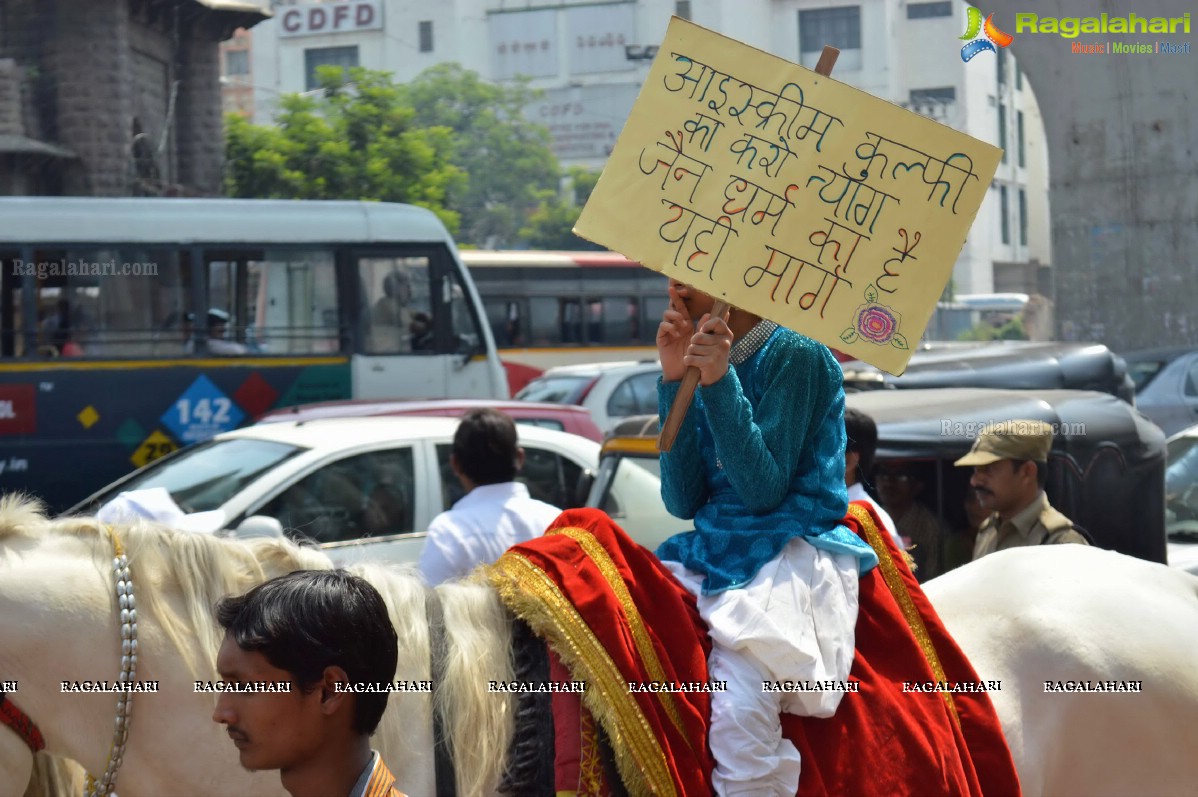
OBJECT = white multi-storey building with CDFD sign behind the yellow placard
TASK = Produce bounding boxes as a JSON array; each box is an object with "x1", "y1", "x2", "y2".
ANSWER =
[{"x1": 250, "y1": 0, "x2": 1051, "y2": 294}]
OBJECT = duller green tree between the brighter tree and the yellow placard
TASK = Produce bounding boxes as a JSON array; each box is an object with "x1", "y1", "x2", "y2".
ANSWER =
[{"x1": 403, "y1": 64, "x2": 559, "y2": 248}]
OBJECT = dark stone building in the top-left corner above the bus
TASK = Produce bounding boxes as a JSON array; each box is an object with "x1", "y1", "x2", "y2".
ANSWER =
[{"x1": 0, "y1": 0, "x2": 264, "y2": 197}]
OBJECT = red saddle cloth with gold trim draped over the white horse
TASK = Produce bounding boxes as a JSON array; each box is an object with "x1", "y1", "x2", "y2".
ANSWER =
[{"x1": 491, "y1": 505, "x2": 1019, "y2": 797}]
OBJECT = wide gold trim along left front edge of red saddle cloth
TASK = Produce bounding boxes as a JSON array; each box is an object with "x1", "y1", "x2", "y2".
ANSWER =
[{"x1": 489, "y1": 550, "x2": 678, "y2": 797}]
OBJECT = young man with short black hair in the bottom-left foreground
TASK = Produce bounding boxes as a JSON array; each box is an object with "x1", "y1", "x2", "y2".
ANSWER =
[{"x1": 212, "y1": 570, "x2": 405, "y2": 797}]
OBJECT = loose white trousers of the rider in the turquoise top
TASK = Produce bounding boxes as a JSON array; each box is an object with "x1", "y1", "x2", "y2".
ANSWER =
[{"x1": 662, "y1": 537, "x2": 859, "y2": 797}]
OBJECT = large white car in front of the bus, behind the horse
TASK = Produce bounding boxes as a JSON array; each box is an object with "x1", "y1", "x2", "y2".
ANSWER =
[{"x1": 71, "y1": 417, "x2": 667, "y2": 564}]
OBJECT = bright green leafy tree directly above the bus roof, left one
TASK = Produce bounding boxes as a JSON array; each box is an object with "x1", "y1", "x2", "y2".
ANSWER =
[{"x1": 225, "y1": 67, "x2": 466, "y2": 231}]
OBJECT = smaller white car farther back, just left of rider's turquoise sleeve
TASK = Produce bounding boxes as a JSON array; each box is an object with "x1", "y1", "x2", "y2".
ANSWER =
[{"x1": 515, "y1": 360, "x2": 661, "y2": 434}]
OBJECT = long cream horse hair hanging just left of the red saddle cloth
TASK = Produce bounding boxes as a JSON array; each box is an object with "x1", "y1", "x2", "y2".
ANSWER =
[{"x1": 434, "y1": 579, "x2": 515, "y2": 797}]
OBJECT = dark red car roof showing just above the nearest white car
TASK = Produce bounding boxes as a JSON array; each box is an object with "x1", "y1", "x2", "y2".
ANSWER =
[{"x1": 258, "y1": 399, "x2": 603, "y2": 442}]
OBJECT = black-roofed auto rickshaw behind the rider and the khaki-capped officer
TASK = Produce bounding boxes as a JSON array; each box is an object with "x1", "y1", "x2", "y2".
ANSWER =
[{"x1": 587, "y1": 387, "x2": 1166, "y2": 572}]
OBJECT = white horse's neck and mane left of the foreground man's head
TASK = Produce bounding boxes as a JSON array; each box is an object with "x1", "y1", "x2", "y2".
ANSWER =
[{"x1": 0, "y1": 496, "x2": 331, "y2": 796}]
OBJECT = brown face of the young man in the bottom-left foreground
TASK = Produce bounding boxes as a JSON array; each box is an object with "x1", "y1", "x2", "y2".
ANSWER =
[{"x1": 212, "y1": 635, "x2": 323, "y2": 771}]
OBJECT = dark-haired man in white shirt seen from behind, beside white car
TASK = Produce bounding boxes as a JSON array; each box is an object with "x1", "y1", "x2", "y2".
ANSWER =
[{"x1": 420, "y1": 407, "x2": 562, "y2": 585}]
